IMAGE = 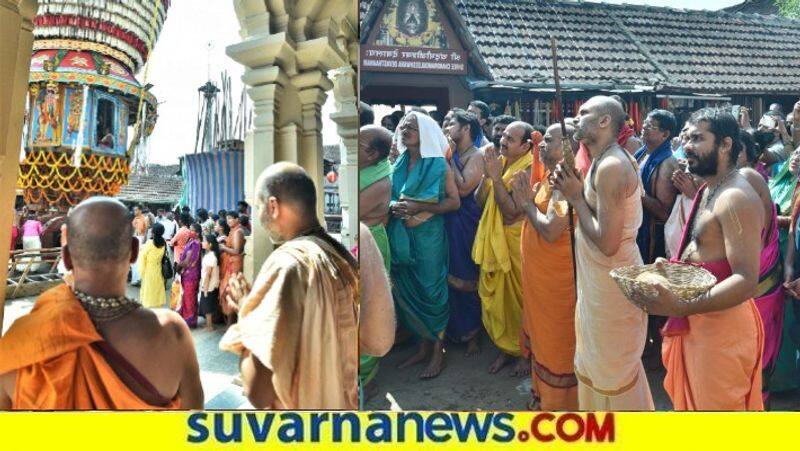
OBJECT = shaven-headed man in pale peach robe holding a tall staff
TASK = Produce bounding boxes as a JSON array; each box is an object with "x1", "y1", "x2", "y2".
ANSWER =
[{"x1": 554, "y1": 96, "x2": 653, "y2": 410}]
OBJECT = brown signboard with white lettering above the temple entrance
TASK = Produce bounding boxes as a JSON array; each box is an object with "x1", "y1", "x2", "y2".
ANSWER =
[{"x1": 361, "y1": 45, "x2": 467, "y2": 75}]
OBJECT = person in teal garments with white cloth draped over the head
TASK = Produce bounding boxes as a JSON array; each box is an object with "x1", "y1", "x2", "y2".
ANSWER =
[{"x1": 387, "y1": 111, "x2": 460, "y2": 379}]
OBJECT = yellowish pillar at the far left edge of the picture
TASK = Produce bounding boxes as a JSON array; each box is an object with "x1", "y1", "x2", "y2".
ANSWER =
[{"x1": 0, "y1": 0, "x2": 38, "y2": 334}]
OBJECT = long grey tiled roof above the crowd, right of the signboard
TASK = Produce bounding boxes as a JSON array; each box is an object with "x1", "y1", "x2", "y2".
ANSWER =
[{"x1": 359, "y1": 0, "x2": 800, "y2": 93}]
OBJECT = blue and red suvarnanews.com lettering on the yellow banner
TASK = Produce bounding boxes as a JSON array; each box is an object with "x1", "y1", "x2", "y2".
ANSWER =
[{"x1": 186, "y1": 412, "x2": 615, "y2": 443}]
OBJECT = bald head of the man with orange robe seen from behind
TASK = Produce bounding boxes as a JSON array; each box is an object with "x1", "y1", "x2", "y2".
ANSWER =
[{"x1": 67, "y1": 196, "x2": 133, "y2": 266}]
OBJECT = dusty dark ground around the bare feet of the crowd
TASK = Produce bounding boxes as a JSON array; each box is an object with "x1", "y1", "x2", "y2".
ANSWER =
[{"x1": 365, "y1": 328, "x2": 800, "y2": 411}]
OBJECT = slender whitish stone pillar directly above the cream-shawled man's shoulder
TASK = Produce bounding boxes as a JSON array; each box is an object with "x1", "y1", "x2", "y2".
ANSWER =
[{"x1": 328, "y1": 66, "x2": 358, "y2": 249}]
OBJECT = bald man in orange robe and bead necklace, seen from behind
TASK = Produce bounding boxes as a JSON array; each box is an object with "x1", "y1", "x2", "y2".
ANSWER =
[{"x1": 0, "y1": 197, "x2": 203, "y2": 410}]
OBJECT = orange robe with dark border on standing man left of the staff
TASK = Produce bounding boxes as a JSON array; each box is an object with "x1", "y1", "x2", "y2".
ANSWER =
[{"x1": 521, "y1": 178, "x2": 578, "y2": 411}]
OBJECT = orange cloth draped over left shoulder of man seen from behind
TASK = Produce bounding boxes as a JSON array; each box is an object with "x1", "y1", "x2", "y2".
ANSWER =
[{"x1": 0, "y1": 285, "x2": 180, "y2": 410}]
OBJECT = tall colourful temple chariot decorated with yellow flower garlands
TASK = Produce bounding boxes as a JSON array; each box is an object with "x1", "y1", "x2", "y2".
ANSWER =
[{"x1": 18, "y1": 0, "x2": 169, "y2": 210}]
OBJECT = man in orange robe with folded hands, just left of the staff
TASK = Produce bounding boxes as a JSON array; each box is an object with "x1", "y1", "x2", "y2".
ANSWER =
[{"x1": 512, "y1": 124, "x2": 578, "y2": 411}]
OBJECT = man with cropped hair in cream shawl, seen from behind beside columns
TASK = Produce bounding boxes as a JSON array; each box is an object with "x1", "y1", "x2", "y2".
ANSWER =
[{"x1": 220, "y1": 163, "x2": 358, "y2": 410}]
